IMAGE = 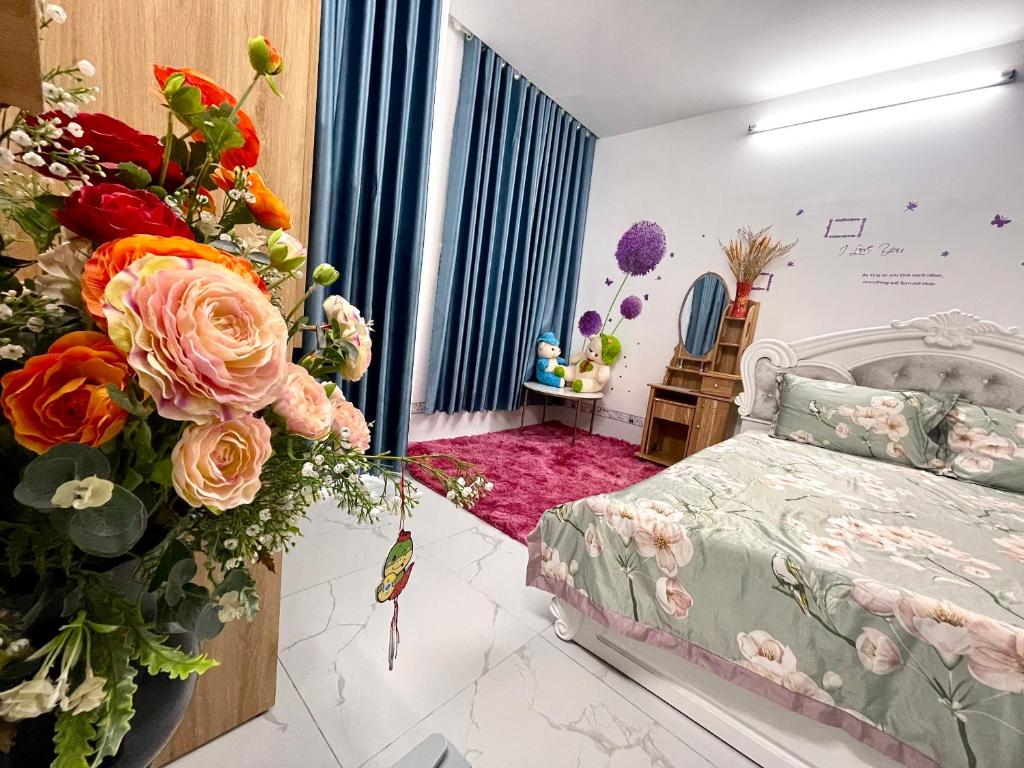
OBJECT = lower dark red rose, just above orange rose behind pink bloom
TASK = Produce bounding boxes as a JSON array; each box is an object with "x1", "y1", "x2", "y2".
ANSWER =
[{"x1": 55, "y1": 184, "x2": 196, "y2": 243}]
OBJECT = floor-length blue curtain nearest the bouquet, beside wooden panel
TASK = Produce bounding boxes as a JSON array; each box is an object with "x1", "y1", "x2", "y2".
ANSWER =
[{"x1": 307, "y1": 0, "x2": 441, "y2": 454}]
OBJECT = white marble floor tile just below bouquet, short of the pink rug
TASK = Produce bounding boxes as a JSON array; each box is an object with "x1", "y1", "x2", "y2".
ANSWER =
[{"x1": 282, "y1": 488, "x2": 479, "y2": 595}]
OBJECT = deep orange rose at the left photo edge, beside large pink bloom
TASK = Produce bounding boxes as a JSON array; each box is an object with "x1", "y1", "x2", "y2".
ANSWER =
[{"x1": 0, "y1": 331, "x2": 131, "y2": 454}]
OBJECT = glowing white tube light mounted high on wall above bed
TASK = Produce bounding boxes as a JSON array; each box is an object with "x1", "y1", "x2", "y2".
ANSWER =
[{"x1": 746, "y1": 70, "x2": 1017, "y2": 133}]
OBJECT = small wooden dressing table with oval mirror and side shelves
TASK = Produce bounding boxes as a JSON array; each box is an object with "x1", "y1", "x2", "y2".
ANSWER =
[{"x1": 636, "y1": 272, "x2": 760, "y2": 467}]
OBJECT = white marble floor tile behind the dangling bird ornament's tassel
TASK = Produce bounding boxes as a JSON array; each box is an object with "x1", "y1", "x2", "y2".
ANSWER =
[{"x1": 281, "y1": 550, "x2": 536, "y2": 768}]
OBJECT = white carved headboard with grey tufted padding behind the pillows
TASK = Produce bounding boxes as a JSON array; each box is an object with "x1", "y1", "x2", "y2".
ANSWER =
[{"x1": 736, "y1": 309, "x2": 1024, "y2": 430}]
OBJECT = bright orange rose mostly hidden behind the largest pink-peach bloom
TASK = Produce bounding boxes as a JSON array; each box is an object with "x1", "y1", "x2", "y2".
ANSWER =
[{"x1": 82, "y1": 234, "x2": 269, "y2": 328}]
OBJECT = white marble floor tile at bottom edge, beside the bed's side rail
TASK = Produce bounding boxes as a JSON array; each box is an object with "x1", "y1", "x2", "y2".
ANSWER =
[{"x1": 364, "y1": 637, "x2": 711, "y2": 768}]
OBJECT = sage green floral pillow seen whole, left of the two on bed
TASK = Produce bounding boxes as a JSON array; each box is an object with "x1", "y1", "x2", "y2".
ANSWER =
[{"x1": 775, "y1": 373, "x2": 956, "y2": 470}]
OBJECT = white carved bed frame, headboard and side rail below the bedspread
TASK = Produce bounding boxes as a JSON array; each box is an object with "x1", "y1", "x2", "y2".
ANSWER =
[{"x1": 551, "y1": 309, "x2": 1024, "y2": 768}]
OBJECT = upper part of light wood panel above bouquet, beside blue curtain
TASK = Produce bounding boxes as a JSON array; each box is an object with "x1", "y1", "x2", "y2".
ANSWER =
[{"x1": 38, "y1": 0, "x2": 319, "y2": 313}]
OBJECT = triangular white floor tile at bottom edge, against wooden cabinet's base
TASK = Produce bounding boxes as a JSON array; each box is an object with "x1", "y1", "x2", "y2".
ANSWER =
[{"x1": 169, "y1": 664, "x2": 339, "y2": 768}]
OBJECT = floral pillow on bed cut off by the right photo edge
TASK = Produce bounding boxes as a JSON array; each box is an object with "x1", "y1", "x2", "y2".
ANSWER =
[{"x1": 944, "y1": 400, "x2": 1024, "y2": 494}]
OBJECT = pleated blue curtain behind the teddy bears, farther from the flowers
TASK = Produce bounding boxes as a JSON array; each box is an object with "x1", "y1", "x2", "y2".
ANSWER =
[{"x1": 426, "y1": 39, "x2": 596, "y2": 413}]
